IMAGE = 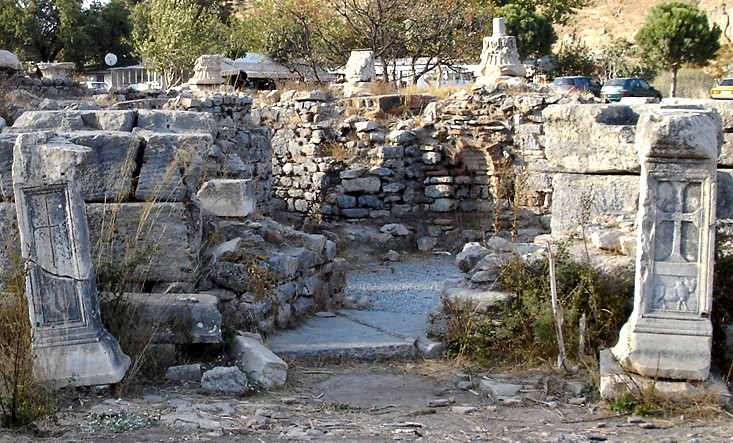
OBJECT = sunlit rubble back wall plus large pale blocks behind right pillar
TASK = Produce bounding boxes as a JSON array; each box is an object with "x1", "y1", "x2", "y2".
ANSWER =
[{"x1": 264, "y1": 86, "x2": 733, "y2": 253}]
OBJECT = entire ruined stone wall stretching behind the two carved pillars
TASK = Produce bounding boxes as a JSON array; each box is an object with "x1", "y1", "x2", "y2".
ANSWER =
[{"x1": 0, "y1": 63, "x2": 733, "y2": 396}]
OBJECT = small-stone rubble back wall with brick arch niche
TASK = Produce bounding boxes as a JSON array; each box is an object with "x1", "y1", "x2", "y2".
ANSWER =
[{"x1": 256, "y1": 83, "x2": 562, "y2": 250}]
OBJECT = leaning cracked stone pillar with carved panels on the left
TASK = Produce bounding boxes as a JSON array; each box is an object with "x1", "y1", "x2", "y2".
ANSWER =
[{"x1": 13, "y1": 133, "x2": 130, "y2": 387}]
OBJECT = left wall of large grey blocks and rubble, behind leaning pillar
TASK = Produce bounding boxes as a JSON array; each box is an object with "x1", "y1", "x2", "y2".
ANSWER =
[{"x1": 0, "y1": 94, "x2": 344, "y2": 333}]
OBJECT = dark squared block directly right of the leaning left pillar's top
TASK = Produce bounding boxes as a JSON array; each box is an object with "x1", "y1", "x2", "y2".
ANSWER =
[{"x1": 65, "y1": 131, "x2": 142, "y2": 203}]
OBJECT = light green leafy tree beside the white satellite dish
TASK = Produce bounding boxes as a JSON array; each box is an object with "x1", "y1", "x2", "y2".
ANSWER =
[{"x1": 131, "y1": 0, "x2": 227, "y2": 86}]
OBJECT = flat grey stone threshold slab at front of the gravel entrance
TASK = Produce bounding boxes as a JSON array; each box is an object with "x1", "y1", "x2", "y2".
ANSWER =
[{"x1": 267, "y1": 311, "x2": 417, "y2": 361}]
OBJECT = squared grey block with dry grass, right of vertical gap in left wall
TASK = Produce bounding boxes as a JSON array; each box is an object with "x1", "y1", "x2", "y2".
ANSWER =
[{"x1": 135, "y1": 131, "x2": 212, "y2": 202}]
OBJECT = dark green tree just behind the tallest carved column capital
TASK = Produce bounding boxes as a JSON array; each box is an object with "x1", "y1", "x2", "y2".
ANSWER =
[{"x1": 497, "y1": 4, "x2": 557, "y2": 57}]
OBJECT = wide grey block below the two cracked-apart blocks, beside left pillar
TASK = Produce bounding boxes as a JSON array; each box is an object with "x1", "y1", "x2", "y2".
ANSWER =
[{"x1": 87, "y1": 203, "x2": 202, "y2": 282}]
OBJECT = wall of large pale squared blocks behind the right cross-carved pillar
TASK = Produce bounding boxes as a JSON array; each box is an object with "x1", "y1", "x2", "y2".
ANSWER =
[{"x1": 541, "y1": 101, "x2": 733, "y2": 233}]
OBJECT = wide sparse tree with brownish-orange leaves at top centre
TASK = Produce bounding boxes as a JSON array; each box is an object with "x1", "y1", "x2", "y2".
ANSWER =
[{"x1": 240, "y1": 0, "x2": 490, "y2": 84}]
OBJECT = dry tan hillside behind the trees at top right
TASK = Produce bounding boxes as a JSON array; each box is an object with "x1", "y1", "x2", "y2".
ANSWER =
[{"x1": 557, "y1": 0, "x2": 733, "y2": 49}]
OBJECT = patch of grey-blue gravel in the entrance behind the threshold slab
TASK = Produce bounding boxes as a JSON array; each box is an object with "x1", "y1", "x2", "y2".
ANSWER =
[{"x1": 346, "y1": 254, "x2": 463, "y2": 317}]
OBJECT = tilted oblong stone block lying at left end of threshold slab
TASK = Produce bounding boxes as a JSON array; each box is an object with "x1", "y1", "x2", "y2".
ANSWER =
[{"x1": 228, "y1": 335, "x2": 288, "y2": 389}]
